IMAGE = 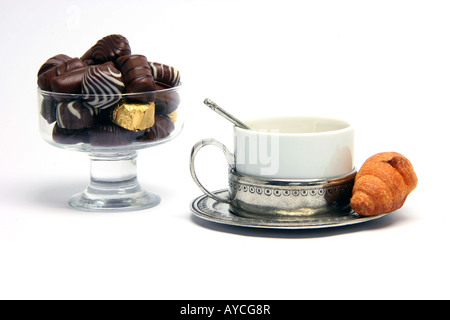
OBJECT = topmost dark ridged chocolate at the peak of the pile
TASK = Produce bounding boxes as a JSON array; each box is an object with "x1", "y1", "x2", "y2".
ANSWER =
[{"x1": 81, "y1": 34, "x2": 131, "y2": 64}]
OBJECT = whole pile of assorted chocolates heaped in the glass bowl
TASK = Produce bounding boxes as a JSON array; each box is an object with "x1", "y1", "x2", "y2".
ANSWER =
[{"x1": 38, "y1": 34, "x2": 180, "y2": 147}]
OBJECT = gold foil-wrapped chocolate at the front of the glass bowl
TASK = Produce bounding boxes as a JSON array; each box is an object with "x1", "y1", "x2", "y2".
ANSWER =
[{"x1": 112, "y1": 102, "x2": 155, "y2": 131}]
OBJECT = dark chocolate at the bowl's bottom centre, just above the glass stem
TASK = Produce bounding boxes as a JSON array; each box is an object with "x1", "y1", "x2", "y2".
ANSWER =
[{"x1": 89, "y1": 124, "x2": 136, "y2": 147}]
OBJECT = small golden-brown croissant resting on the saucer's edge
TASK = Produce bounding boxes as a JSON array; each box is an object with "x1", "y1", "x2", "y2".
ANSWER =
[{"x1": 350, "y1": 152, "x2": 418, "y2": 216}]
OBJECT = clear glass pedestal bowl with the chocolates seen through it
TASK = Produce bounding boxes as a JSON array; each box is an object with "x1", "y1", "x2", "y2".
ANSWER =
[{"x1": 38, "y1": 86, "x2": 183, "y2": 211}]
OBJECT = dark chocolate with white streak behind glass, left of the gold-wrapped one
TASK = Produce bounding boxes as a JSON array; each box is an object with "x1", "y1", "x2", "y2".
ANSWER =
[{"x1": 56, "y1": 100, "x2": 95, "y2": 129}]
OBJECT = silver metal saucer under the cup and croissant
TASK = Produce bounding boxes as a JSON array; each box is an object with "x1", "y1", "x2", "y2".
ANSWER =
[{"x1": 191, "y1": 189, "x2": 386, "y2": 229}]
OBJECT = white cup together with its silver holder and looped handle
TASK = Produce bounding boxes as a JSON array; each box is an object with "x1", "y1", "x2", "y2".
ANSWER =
[{"x1": 190, "y1": 117, "x2": 355, "y2": 218}]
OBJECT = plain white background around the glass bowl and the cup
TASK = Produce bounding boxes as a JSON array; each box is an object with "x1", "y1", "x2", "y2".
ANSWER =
[{"x1": 0, "y1": 0, "x2": 450, "y2": 299}]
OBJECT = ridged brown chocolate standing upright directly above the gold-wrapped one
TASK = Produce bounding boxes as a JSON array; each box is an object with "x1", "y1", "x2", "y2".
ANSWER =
[{"x1": 116, "y1": 54, "x2": 156, "y2": 102}]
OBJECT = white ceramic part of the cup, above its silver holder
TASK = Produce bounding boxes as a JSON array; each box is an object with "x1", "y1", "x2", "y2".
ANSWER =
[{"x1": 234, "y1": 117, "x2": 354, "y2": 179}]
